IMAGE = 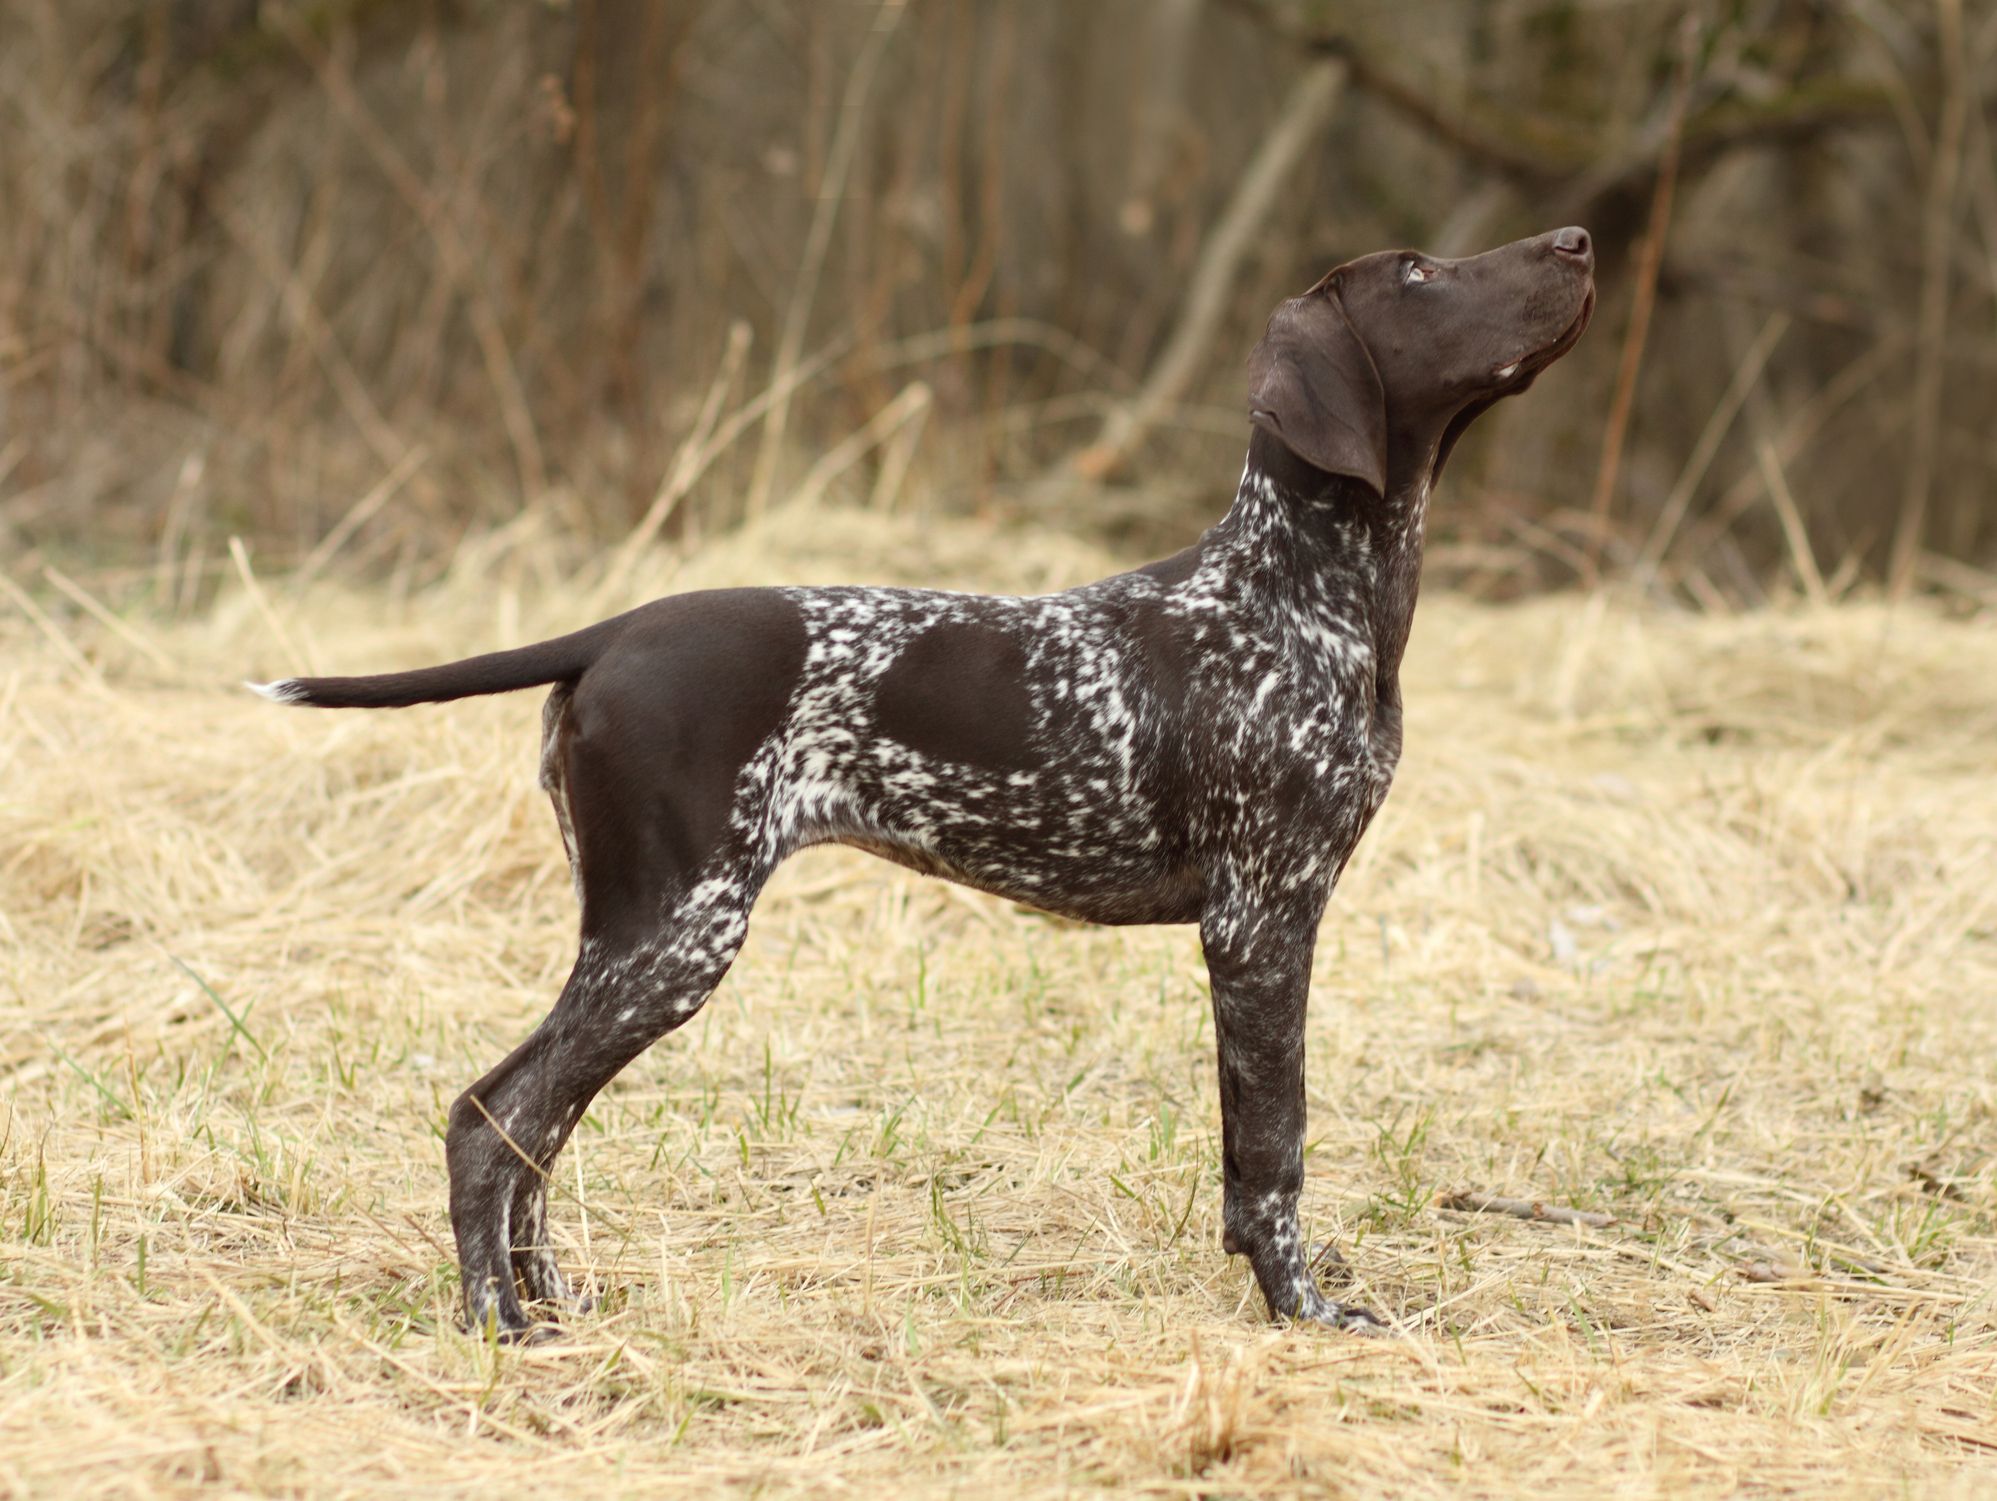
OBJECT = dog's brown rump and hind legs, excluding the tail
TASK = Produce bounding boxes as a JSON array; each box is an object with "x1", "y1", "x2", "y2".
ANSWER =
[{"x1": 445, "y1": 591, "x2": 805, "y2": 1335}]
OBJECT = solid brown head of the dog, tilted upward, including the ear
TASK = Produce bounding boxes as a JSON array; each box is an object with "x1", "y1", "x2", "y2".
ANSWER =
[{"x1": 1248, "y1": 228, "x2": 1596, "y2": 495}]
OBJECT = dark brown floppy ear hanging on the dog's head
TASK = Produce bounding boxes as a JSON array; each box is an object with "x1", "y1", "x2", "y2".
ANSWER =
[{"x1": 1248, "y1": 277, "x2": 1386, "y2": 495}]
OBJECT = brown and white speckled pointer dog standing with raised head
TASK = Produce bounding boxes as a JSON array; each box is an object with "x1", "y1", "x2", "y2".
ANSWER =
[{"x1": 252, "y1": 228, "x2": 1596, "y2": 1339}]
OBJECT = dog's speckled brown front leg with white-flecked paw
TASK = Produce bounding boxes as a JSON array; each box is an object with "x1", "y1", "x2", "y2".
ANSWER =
[{"x1": 1200, "y1": 884, "x2": 1382, "y2": 1329}]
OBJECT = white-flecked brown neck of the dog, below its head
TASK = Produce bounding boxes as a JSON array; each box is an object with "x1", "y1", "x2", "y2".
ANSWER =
[{"x1": 1212, "y1": 431, "x2": 1434, "y2": 695}]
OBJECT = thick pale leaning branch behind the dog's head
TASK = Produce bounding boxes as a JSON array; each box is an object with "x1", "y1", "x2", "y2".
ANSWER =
[{"x1": 1068, "y1": 60, "x2": 1346, "y2": 479}]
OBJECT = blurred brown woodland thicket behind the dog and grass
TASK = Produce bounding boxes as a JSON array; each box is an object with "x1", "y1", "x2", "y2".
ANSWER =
[{"x1": 0, "y1": 0, "x2": 1997, "y2": 599}]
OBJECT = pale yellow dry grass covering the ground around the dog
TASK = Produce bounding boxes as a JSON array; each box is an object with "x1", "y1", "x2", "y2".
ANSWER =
[{"x1": 0, "y1": 513, "x2": 1997, "y2": 1497}]
